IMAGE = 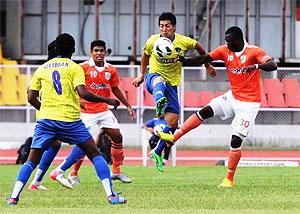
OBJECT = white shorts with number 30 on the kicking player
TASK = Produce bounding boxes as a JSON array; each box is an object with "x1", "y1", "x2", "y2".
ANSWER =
[{"x1": 208, "y1": 91, "x2": 260, "y2": 137}]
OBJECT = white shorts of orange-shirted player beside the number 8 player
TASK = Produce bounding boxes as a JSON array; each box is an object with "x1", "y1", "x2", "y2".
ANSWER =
[{"x1": 81, "y1": 110, "x2": 120, "y2": 139}]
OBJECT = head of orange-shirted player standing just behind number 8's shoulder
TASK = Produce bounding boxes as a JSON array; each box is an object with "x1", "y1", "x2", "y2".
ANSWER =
[{"x1": 90, "y1": 40, "x2": 107, "y2": 66}]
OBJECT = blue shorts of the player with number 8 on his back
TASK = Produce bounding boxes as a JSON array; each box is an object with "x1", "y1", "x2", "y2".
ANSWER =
[{"x1": 31, "y1": 119, "x2": 92, "y2": 149}]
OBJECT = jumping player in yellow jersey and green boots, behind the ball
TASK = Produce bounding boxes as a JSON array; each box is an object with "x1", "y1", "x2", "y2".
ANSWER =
[{"x1": 132, "y1": 12, "x2": 216, "y2": 172}]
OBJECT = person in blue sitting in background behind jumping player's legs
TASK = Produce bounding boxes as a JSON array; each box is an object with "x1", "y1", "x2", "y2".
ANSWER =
[{"x1": 142, "y1": 115, "x2": 171, "y2": 163}]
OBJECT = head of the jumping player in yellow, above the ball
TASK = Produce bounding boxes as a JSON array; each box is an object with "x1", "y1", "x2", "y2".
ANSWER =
[{"x1": 158, "y1": 12, "x2": 176, "y2": 39}]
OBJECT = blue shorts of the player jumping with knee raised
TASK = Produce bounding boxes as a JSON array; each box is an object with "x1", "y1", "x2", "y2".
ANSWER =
[{"x1": 145, "y1": 73, "x2": 180, "y2": 114}]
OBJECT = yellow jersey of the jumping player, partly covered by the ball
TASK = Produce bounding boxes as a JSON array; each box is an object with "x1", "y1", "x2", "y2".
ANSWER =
[{"x1": 143, "y1": 33, "x2": 197, "y2": 86}]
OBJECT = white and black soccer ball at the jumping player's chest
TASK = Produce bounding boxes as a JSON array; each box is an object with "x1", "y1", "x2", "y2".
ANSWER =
[{"x1": 153, "y1": 37, "x2": 174, "y2": 57}]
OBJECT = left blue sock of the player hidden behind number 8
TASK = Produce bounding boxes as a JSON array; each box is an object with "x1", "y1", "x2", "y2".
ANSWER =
[{"x1": 36, "y1": 144, "x2": 61, "y2": 182}]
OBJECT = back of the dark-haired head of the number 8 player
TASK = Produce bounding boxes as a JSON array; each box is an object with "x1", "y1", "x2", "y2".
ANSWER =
[{"x1": 55, "y1": 33, "x2": 75, "y2": 58}]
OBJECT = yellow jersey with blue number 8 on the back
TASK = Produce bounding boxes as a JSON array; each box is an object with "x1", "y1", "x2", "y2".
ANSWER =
[{"x1": 29, "y1": 58, "x2": 85, "y2": 122}]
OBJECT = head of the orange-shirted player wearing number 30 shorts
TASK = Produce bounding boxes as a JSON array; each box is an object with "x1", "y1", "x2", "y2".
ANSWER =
[{"x1": 225, "y1": 26, "x2": 244, "y2": 52}]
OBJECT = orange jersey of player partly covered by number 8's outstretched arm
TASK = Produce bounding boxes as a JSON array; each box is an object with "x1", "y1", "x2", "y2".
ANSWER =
[{"x1": 80, "y1": 58, "x2": 120, "y2": 114}]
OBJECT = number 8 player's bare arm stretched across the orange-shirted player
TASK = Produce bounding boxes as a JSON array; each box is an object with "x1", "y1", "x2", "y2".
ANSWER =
[{"x1": 76, "y1": 85, "x2": 120, "y2": 109}]
